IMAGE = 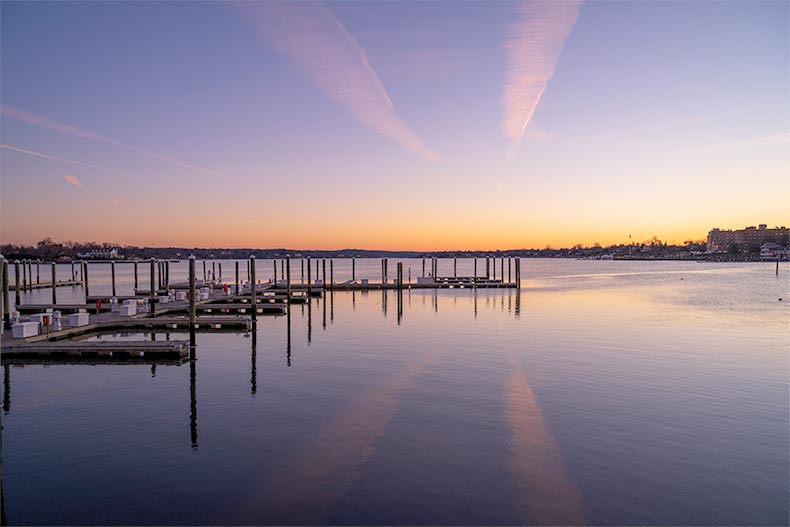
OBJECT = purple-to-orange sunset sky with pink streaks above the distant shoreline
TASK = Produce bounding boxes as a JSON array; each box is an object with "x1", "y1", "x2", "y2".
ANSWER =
[{"x1": 0, "y1": 0, "x2": 790, "y2": 250}]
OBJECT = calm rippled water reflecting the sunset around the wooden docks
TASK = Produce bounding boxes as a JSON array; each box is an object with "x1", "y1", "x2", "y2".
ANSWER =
[{"x1": 2, "y1": 259, "x2": 790, "y2": 525}]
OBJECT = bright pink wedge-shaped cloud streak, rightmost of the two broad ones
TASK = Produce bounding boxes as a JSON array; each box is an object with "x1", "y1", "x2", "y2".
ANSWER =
[{"x1": 502, "y1": 0, "x2": 582, "y2": 158}]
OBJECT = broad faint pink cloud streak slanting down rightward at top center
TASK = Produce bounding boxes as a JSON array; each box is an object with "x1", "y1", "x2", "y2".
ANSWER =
[{"x1": 237, "y1": 2, "x2": 441, "y2": 162}]
